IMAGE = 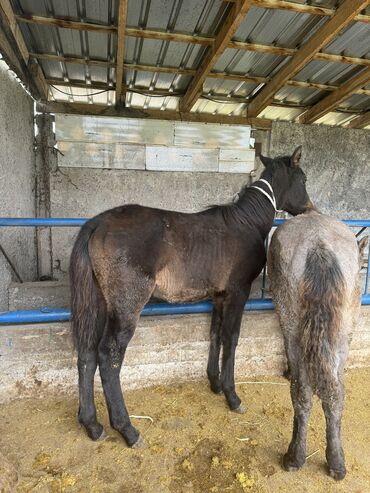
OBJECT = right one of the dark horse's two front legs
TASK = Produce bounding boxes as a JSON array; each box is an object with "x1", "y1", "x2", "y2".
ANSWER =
[{"x1": 221, "y1": 290, "x2": 249, "y2": 413}]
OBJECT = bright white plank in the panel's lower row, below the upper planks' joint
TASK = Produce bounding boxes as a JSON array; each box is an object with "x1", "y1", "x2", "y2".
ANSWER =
[{"x1": 146, "y1": 146, "x2": 219, "y2": 172}]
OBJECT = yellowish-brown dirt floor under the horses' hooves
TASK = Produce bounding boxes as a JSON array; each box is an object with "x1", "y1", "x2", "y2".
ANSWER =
[{"x1": 0, "y1": 368, "x2": 370, "y2": 493}]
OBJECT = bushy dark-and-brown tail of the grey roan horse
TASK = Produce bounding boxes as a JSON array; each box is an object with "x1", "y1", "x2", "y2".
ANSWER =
[{"x1": 301, "y1": 244, "x2": 345, "y2": 390}]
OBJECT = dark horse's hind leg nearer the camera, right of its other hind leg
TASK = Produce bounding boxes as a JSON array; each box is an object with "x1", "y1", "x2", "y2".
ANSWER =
[{"x1": 99, "y1": 315, "x2": 143, "y2": 447}]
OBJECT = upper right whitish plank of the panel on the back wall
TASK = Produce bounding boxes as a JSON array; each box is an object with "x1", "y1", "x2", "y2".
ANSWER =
[{"x1": 174, "y1": 122, "x2": 251, "y2": 148}]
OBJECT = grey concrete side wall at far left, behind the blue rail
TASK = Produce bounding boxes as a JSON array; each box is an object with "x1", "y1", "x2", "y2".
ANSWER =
[{"x1": 0, "y1": 60, "x2": 37, "y2": 310}]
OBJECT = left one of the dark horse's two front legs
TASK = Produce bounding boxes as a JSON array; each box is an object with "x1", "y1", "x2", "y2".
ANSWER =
[{"x1": 207, "y1": 298, "x2": 222, "y2": 394}]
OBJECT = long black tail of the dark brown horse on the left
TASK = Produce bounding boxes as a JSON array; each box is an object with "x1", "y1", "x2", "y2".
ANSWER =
[{"x1": 69, "y1": 221, "x2": 106, "y2": 349}]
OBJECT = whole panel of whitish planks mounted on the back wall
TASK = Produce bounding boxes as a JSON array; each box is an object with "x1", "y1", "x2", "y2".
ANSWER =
[{"x1": 55, "y1": 114, "x2": 255, "y2": 173}]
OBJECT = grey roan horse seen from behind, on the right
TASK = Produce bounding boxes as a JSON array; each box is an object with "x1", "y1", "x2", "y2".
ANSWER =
[{"x1": 268, "y1": 210, "x2": 367, "y2": 479}]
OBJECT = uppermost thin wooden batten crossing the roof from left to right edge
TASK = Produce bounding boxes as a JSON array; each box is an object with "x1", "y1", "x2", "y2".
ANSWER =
[{"x1": 17, "y1": 16, "x2": 370, "y2": 66}]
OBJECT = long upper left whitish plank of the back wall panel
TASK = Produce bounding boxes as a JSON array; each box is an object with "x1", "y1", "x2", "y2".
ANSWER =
[{"x1": 55, "y1": 114, "x2": 174, "y2": 145}]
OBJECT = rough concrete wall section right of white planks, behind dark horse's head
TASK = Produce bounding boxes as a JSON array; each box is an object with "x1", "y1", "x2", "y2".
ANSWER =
[{"x1": 269, "y1": 122, "x2": 370, "y2": 219}]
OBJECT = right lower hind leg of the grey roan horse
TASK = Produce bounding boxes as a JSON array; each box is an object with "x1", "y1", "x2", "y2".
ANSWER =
[{"x1": 320, "y1": 382, "x2": 346, "y2": 480}]
